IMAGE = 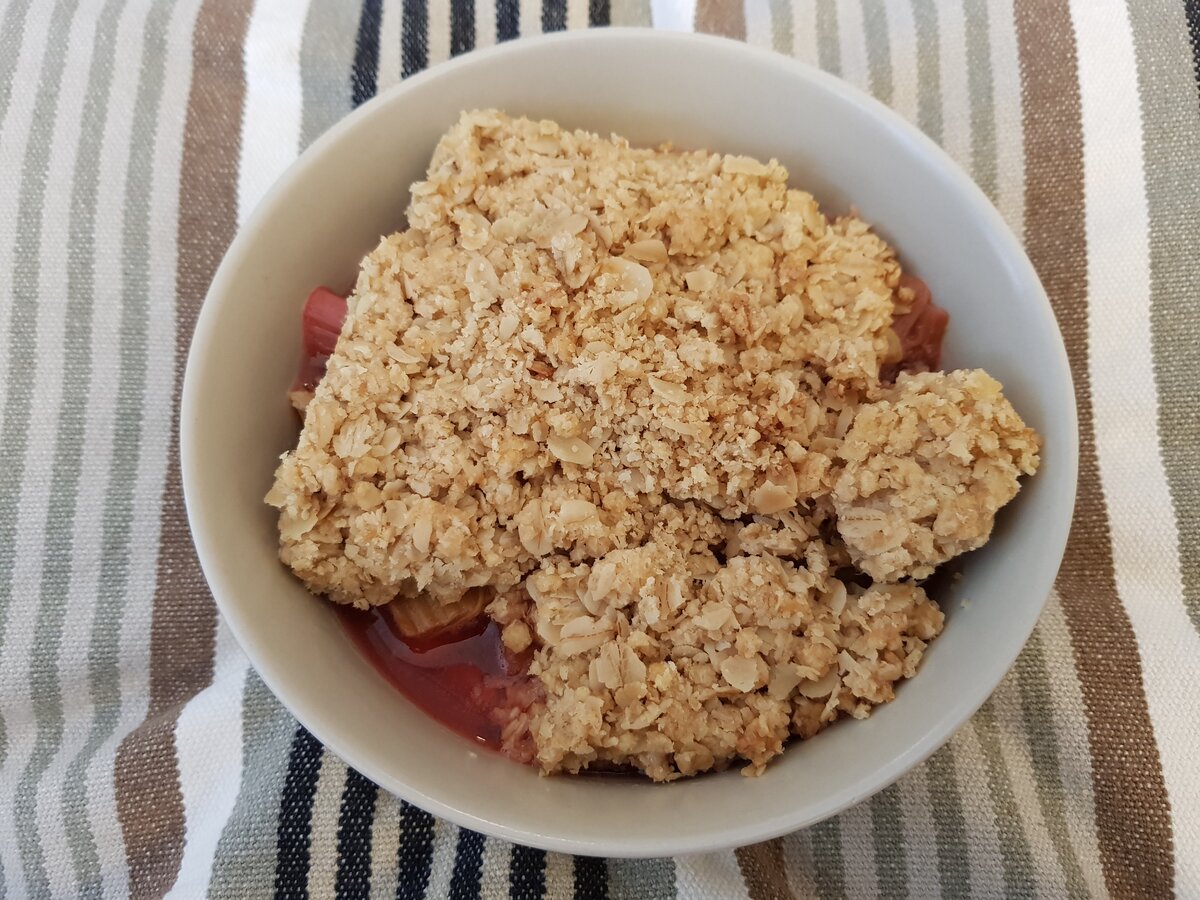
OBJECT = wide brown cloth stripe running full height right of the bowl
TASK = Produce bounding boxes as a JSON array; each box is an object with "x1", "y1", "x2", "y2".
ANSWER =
[{"x1": 1015, "y1": 0, "x2": 1174, "y2": 898}]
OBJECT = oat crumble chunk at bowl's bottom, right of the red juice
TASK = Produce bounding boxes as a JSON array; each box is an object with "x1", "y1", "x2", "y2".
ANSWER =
[{"x1": 499, "y1": 536, "x2": 943, "y2": 781}]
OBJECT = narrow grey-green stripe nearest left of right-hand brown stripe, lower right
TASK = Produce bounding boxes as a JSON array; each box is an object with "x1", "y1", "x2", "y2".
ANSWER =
[{"x1": 1014, "y1": 630, "x2": 1087, "y2": 900}]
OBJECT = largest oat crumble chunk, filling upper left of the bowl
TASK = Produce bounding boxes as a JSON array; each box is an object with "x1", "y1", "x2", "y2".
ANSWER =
[{"x1": 262, "y1": 113, "x2": 900, "y2": 605}]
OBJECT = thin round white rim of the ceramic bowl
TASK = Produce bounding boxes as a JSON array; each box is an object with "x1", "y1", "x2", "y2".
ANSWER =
[{"x1": 178, "y1": 28, "x2": 1079, "y2": 858}]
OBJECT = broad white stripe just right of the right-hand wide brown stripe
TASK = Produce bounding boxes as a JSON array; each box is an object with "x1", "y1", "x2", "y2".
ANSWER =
[{"x1": 1070, "y1": 0, "x2": 1200, "y2": 896}]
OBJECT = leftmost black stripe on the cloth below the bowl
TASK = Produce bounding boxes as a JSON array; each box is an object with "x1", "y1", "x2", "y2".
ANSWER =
[{"x1": 275, "y1": 727, "x2": 323, "y2": 900}]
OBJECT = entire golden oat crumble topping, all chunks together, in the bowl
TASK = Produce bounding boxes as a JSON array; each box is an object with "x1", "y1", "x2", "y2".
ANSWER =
[{"x1": 268, "y1": 112, "x2": 1037, "y2": 780}]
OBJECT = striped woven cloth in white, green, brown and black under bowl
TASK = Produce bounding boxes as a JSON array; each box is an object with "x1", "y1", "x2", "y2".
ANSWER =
[{"x1": 0, "y1": 0, "x2": 1200, "y2": 900}]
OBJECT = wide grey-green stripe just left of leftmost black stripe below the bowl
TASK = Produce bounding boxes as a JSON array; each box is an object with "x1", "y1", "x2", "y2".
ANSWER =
[{"x1": 209, "y1": 671, "x2": 300, "y2": 898}]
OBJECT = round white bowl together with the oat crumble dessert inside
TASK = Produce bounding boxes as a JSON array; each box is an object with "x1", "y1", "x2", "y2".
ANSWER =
[{"x1": 182, "y1": 31, "x2": 1075, "y2": 856}]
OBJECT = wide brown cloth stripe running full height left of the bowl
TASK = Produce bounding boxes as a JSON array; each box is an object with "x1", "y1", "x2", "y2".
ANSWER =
[{"x1": 115, "y1": 0, "x2": 251, "y2": 898}]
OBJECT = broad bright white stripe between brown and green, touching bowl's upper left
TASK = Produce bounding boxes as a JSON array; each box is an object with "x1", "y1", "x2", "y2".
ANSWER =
[{"x1": 238, "y1": 0, "x2": 310, "y2": 221}]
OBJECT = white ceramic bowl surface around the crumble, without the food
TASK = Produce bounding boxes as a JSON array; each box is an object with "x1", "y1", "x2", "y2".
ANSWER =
[{"x1": 180, "y1": 30, "x2": 1076, "y2": 857}]
